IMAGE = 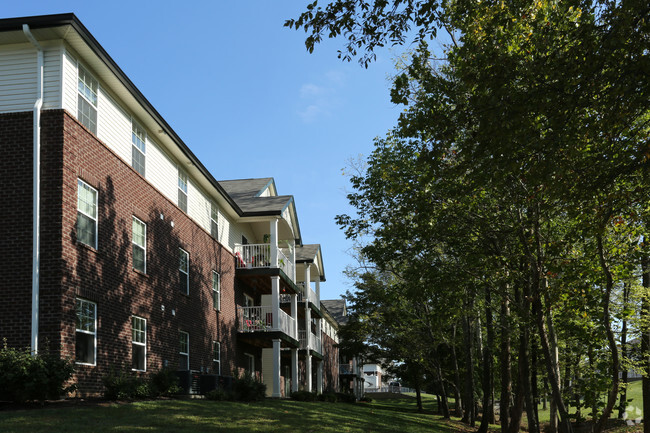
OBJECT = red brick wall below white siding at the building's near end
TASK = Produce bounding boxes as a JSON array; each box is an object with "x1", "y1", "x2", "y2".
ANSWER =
[{"x1": 0, "y1": 110, "x2": 236, "y2": 395}]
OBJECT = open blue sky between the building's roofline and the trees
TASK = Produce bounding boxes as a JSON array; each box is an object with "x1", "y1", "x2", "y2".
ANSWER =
[{"x1": 2, "y1": 0, "x2": 420, "y2": 299}]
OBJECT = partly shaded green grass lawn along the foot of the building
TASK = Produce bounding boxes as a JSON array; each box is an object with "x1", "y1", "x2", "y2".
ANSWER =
[{"x1": 0, "y1": 399, "x2": 466, "y2": 433}]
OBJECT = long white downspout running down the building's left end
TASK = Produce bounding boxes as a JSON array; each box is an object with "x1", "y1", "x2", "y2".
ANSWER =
[{"x1": 23, "y1": 24, "x2": 43, "y2": 355}]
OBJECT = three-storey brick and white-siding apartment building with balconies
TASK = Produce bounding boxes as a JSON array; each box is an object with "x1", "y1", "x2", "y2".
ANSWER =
[{"x1": 0, "y1": 14, "x2": 338, "y2": 397}]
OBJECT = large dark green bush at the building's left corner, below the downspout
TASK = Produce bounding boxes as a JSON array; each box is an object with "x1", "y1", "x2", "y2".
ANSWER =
[{"x1": 0, "y1": 340, "x2": 76, "y2": 403}]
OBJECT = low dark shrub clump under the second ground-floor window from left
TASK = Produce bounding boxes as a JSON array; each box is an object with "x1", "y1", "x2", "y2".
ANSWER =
[{"x1": 102, "y1": 367, "x2": 180, "y2": 400}]
